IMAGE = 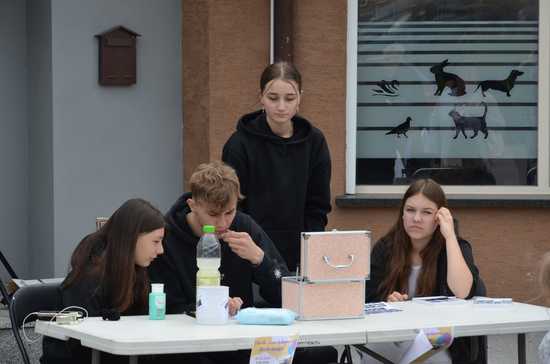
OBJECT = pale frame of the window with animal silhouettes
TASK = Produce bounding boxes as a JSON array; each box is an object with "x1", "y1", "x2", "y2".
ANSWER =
[{"x1": 346, "y1": 0, "x2": 550, "y2": 199}]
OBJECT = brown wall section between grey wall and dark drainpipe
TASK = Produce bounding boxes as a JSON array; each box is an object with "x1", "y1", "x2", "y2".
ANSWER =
[{"x1": 182, "y1": 0, "x2": 269, "y2": 182}]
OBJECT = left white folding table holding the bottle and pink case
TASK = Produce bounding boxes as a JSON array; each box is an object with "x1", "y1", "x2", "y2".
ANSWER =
[{"x1": 35, "y1": 315, "x2": 366, "y2": 364}]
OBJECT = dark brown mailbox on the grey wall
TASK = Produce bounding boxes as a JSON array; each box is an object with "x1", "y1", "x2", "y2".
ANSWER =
[{"x1": 96, "y1": 26, "x2": 139, "y2": 86}]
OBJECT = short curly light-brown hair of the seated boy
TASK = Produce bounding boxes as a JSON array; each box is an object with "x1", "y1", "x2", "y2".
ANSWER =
[{"x1": 189, "y1": 161, "x2": 244, "y2": 209}]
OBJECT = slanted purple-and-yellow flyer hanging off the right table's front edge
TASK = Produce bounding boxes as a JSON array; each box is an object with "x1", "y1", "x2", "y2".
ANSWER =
[{"x1": 399, "y1": 327, "x2": 453, "y2": 364}]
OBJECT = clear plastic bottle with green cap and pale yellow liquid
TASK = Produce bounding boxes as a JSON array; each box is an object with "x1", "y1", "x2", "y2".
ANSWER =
[{"x1": 197, "y1": 225, "x2": 221, "y2": 287}]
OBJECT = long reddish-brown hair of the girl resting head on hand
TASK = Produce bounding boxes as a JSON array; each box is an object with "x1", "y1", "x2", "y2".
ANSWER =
[{"x1": 378, "y1": 179, "x2": 447, "y2": 299}]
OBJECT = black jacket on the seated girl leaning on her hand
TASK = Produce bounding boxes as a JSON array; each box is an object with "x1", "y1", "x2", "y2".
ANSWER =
[{"x1": 365, "y1": 239, "x2": 485, "y2": 364}]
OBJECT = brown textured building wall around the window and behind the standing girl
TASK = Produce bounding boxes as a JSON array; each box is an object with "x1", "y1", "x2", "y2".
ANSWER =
[{"x1": 183, "y1": 0, "x2": 550, "y2": 302}]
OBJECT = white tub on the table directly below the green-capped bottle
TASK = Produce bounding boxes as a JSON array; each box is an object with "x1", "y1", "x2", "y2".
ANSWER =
[{"x1": 196, "y1": 286, "x2": 229, "y2": 325}]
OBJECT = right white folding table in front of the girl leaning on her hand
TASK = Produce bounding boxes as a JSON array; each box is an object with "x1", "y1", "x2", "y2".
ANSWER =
[{"x1": 365, "y1": 300, "x2": 550, "y2": 364}]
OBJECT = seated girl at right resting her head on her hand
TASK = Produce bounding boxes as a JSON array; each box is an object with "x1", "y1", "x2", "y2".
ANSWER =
[{"x1": 366, "y1": 179, "x2": 484, "y2": 363}]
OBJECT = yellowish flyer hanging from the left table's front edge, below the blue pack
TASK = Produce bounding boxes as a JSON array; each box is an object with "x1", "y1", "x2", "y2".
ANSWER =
[{"x1": 250, "y1": 335, "x2": 298, "y2": 364}]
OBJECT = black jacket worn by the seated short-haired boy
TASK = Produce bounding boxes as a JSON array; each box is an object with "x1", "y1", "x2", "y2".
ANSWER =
[{"x1": 148, "y1": 193, "x2": 289, "y2": 313}]
